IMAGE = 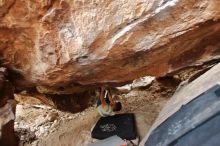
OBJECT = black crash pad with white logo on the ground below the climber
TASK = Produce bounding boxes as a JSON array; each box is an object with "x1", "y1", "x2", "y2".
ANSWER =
[{"x1": 91, "y1": 113, "x2": 137, "y2": 140}]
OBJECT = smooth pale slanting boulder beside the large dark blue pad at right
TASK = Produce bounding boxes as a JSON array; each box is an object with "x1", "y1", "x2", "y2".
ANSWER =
[{"x1": 140, "y1": 63, "x2": 220, "y2": 146}]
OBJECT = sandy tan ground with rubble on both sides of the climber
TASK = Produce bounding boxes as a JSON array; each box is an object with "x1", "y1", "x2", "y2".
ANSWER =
[{"x1": 15, "y1": 78, "x2": 176, "y2": 146}]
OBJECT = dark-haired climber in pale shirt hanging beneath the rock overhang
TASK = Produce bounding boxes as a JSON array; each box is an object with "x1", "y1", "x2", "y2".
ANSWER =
[{"x1": 96, "y1": 86, "x2": 121, "y2": 117}]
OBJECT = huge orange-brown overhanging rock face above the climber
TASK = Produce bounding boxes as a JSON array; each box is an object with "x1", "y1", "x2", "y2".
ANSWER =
[{"x1": 0, "y1": 0, "x2": 220, "y2": 91}]
